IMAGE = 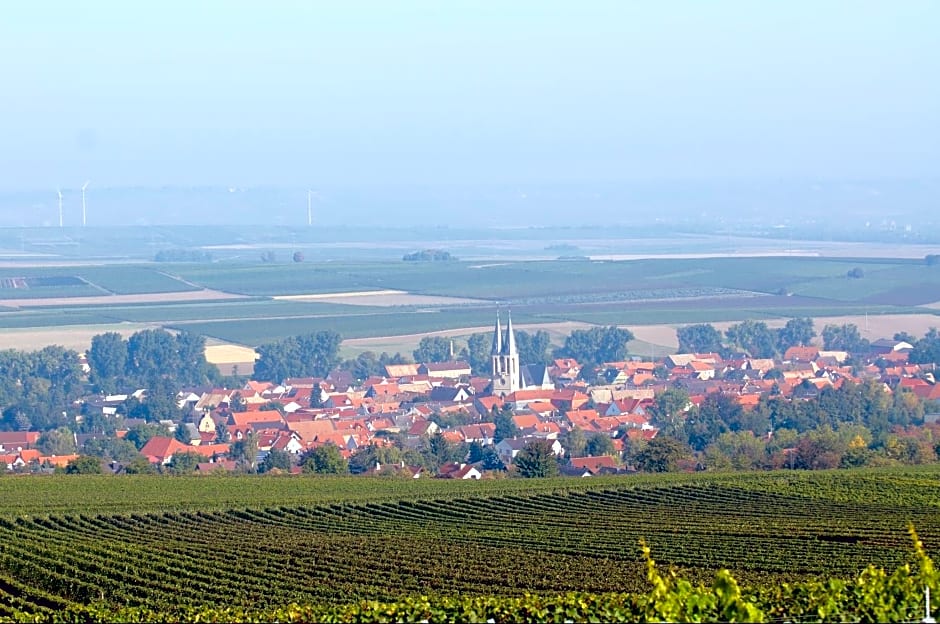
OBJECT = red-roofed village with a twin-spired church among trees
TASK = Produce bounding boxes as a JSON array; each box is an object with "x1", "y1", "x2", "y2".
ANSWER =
[{"x1": 0, "y1": 317, "x2": 940, "y2": 479}]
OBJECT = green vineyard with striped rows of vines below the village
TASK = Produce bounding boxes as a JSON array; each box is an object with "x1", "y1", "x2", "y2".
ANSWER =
[{"x1": 0, "y1": 469, "x2": 940, "y2": 619}]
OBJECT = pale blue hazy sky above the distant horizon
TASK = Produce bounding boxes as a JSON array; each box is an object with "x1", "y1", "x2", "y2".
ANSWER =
[{"x1": 0, "y1": 0, "x2": 940, "y2": 190}]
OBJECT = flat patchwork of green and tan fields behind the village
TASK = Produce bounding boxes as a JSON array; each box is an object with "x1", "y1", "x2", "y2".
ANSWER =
[{"x1": 0, "y1": 256, "x2": 940, "y2": 354}]
